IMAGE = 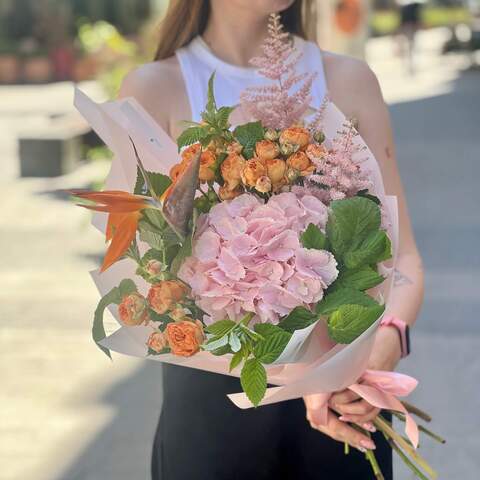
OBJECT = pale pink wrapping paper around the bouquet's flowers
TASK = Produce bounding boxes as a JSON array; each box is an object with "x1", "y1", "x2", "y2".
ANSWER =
[{"x1": 75, "y1": 89, "x2": 398, "y2": 408}]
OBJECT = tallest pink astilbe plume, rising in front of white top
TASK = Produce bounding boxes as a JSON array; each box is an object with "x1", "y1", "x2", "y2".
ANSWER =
[{"x1": 240, "y1": 13, "x2": 316, "y2": 128}]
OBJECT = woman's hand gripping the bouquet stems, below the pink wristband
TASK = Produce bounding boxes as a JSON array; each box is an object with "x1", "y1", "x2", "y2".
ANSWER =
[{"x1": 304, "y1": 327, "x2": 401, "y2": 451}]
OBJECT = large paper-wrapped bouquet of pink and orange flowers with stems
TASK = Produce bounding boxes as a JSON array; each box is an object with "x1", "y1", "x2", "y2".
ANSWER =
[{"x1": 72, "y1": 15, "x2": 442, "y2": 478}]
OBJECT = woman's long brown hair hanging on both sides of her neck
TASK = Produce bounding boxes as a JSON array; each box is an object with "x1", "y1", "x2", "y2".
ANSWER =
[{"x1": 155, "y1": 0, "x2": 316, "y2": 60}]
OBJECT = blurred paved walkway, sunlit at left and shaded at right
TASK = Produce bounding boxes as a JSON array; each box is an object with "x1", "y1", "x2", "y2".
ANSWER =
[{"x1": 0, "y1": 32, "x2": 480, "y2": 480}]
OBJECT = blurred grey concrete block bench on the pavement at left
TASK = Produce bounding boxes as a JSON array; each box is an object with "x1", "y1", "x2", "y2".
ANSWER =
[{"x1": 18, "y1": 115, "x2": 90, "y2": 177}]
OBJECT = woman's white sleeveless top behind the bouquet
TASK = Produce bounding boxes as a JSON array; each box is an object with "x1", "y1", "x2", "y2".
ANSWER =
[{"x1": 176, "y1": 36, "x2": 327, "y2": 122}]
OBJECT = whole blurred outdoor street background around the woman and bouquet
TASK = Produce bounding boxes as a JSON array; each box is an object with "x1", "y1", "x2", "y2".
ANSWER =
[{"x1": 0, "y1": 0, "x2": 480, "y2": 480}]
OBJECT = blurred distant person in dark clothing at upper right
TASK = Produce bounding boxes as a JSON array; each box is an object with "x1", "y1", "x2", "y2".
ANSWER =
[{"x1": 395, "y1": 0, "x2": 425, "y2": 75}]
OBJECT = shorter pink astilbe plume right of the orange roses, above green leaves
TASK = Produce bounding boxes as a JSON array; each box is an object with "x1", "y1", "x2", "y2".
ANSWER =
[{"x1": 306, "y1": 121, "x2": 372, "y2": 203}]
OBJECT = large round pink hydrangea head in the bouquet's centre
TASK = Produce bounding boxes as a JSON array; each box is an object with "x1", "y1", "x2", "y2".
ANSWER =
[{"x1": 178, "y1": 192, "x2": 338, "y2": 323}]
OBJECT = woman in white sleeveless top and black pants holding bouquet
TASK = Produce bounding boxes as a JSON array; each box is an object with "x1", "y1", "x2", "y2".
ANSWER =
[{"x1": 121, "y1": 0, "x2": 423, "y2": 480}]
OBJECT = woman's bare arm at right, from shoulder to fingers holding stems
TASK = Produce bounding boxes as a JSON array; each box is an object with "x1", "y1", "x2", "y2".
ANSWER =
[{"x1": 305, "y1": 54, "x2": 423, "y2": 448}]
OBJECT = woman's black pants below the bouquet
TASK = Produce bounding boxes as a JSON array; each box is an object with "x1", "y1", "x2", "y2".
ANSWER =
[{"x1": 152, "y1": 365, "x2": 392, "y2": 480}]
